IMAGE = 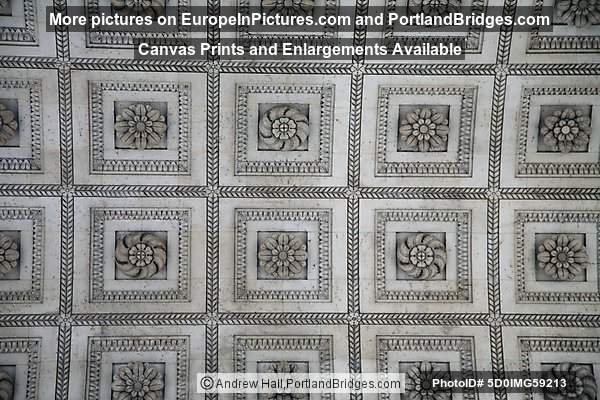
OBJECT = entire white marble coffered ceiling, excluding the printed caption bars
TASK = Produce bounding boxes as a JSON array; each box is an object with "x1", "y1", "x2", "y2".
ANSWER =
[{"x1": 0, "y1": 0, "x2": 600, "y2": 400}]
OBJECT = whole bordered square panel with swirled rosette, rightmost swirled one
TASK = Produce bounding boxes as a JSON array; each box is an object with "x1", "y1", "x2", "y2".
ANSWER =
[{"x1": 374, "y1": 209, "x2": 473, "y2": 302}]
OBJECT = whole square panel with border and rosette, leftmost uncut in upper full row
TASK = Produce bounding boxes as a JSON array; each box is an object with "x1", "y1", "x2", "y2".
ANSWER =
[{"x1": 88, "y1": 81, "x2": 192, "y2": 175}]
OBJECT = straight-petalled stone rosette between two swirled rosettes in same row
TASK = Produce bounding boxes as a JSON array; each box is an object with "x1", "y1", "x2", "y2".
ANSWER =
[{"x1": 258, "y1": 232, "x2": 308, "y2": 279}]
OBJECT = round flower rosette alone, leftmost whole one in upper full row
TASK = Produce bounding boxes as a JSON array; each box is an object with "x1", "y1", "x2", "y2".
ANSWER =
[{"x1": 115, "y1": 103, "x2": 167, "y2": 150}]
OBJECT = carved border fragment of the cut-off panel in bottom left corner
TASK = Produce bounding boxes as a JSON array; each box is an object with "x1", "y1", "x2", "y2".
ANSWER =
[{"x1": 0, "y1": 337, "x2": 44, "y2": 399}]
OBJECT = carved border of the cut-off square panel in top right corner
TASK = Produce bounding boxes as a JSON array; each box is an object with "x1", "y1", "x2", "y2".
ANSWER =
[{"x1": 528, "y1": 0, "x2": 600, "y2": 53}]
